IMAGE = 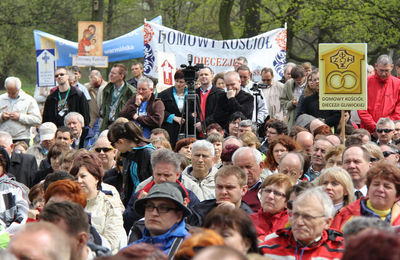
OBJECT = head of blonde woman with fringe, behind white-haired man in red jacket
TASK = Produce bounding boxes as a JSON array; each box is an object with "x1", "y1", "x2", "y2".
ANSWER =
[{"x1": 316, "y1": 167, "x2": 355, "y2": 212}]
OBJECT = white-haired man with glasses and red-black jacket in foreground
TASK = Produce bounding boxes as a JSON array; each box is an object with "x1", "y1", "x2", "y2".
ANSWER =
[{"x1": 260, "y1": 187, "x2": 344, "y2": 259}]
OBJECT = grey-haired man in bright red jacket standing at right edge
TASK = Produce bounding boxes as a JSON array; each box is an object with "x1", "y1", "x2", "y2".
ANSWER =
[{"x1": 358, "y1": 55, "x2": 400, "y2": 133}]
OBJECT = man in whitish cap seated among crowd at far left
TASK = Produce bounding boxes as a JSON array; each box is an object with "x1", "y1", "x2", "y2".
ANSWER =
[{"x1": 27, "y1": 122, "x2": 57, "y2": 169}]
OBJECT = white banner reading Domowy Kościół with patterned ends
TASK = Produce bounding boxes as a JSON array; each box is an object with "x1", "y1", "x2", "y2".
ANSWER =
[{"x1": 144, "y1": 22, "x2": 286, "y2": 81}]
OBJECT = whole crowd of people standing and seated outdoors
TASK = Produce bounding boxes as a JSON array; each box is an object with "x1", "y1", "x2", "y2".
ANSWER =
[{"x1": 0, "y1": 55, "x2": 400, "y2": 260}]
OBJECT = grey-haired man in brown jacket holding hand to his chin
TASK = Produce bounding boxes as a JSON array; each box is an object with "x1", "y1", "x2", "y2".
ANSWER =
[{"x1": 119, "y1": 77, "x2": 165, "y2": 138}]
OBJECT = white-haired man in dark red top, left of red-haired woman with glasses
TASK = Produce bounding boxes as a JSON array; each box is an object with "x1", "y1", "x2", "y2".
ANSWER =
[{"x1": 232, "y1": 147, "x2": 264, "y2": 212}]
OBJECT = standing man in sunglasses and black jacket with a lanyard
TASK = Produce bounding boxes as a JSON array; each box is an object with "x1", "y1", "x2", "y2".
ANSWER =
[{"x1": 43, "y1": 68, "x2": 90, "y2": 127}]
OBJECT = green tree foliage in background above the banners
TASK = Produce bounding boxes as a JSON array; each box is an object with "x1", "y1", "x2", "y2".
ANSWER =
[{"x1": 0, "y1": 0, "x2": 400, "y2": 89}]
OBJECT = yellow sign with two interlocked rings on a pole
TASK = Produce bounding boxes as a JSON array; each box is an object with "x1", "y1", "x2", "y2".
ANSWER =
[{"x1": 319, "y1": 43, "x2": 367, "y2": 110}]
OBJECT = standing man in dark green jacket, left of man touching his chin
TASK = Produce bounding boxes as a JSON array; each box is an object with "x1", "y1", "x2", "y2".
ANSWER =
[{"x1": 100, "y1": 64, "x2": 136, "y2": 132}]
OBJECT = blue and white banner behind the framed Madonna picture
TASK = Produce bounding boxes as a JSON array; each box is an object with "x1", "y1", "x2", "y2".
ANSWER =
[{"x1": 33, "y1": 16, "x2": 162, "y2": 66}]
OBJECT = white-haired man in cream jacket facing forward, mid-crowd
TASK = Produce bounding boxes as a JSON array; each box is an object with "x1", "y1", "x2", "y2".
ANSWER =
[{"x1": 182, "y1": 140, "x2": 218, "y2": 201}]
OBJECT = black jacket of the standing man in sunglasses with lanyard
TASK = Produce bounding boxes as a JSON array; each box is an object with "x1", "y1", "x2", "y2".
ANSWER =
[{"x1": 43, "y1": 87, "x2": 90, "y2": 126}]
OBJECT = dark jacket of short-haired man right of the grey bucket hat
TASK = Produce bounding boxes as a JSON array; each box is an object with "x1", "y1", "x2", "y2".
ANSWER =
[{"x1": 186, "y1": 199, "x2": 254, "y2": 227}]
